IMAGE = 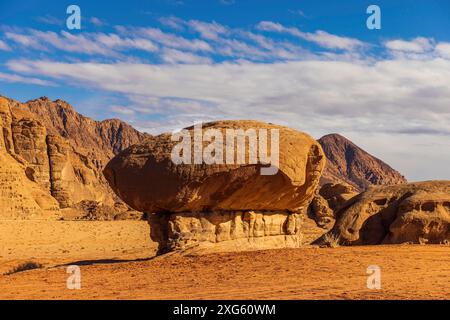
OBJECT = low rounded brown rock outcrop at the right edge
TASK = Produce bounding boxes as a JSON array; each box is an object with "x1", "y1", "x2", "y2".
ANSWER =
[{"x1": 319, "y1": 181, "x2": 450, "y2": 245}]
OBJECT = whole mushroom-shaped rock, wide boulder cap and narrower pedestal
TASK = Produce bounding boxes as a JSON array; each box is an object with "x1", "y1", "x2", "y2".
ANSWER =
[{"x1": 104, "y1": 121, "x2": 325, "y2": 250}]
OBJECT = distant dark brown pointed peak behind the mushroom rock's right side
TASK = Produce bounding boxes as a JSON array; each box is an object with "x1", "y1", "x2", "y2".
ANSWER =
[{"x1": 318, "y1": 134, "x2": 407, "y2": 191}]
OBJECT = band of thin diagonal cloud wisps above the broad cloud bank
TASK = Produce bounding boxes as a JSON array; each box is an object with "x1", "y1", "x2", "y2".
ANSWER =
[{"x1": 1, "y1": 17, "x2": 362, "y2": 64}]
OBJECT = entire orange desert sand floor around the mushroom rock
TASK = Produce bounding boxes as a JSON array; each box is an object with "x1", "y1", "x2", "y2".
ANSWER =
[{"x1": 0, "y1": 221, "x2": 450, "y2": 299}]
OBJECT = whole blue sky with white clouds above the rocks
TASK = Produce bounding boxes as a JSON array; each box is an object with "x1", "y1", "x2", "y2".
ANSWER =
[{"x1": 0, "y1": 0, "x2": 450, "y2": 180}]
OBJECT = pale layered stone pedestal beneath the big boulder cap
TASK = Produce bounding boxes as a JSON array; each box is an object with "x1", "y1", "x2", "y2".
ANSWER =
[{"x1": 149, "y1": 211, "x2": 302, "y2": 253}]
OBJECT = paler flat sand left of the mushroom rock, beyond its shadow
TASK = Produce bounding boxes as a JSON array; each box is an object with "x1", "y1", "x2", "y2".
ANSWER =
[{"x1": 0, "y1": 220, "x2": 156, "y2": 274}]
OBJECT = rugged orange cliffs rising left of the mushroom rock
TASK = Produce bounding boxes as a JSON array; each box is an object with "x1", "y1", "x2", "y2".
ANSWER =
[{"x1": 0, "y1": 97, "x2": 145, "y2": 218}]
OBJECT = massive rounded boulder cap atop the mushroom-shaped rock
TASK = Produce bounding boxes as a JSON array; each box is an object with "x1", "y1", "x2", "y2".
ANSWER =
[{"x1": 104, "y1": 121, "x2": 325, "y2": 213}]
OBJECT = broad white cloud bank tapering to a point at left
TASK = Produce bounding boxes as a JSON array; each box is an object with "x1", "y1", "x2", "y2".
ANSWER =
[{"x1": 7, "y1": 59, "x2": 450, "y2": 136}]
